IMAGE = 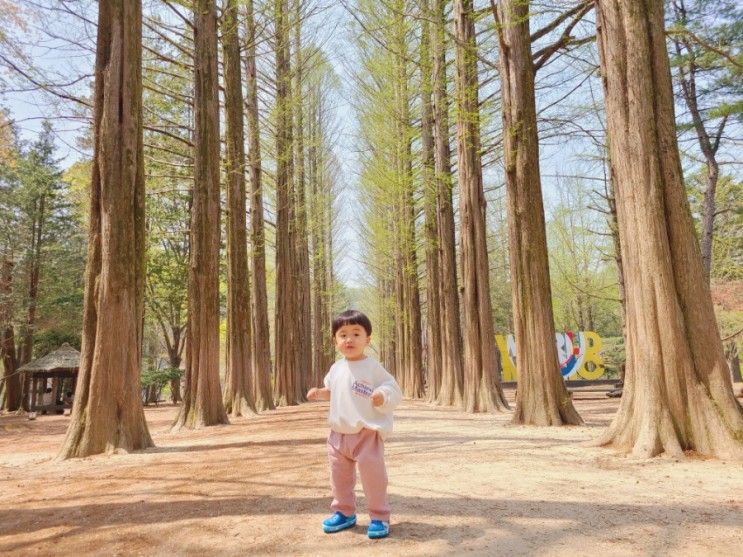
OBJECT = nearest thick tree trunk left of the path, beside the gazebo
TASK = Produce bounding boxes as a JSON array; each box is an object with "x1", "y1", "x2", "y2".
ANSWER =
[{"x1": 60, "y1": 0, "x2": 153, "y2": 458}]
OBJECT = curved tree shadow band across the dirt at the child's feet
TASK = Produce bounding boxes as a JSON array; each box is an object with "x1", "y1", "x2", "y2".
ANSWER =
[{"x1": 0, "y1": 494, "x2": 743, "y2": 552}]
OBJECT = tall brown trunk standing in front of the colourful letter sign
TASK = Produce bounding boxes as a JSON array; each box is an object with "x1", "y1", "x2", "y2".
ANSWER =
[{"x1": 498, "y1": 0, "x2": 583, "y2": 426}]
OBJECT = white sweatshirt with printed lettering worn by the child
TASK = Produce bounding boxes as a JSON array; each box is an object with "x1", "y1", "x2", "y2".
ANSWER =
[{"x1": 324, "y1": 357, "x2": 402, "y2": 439}]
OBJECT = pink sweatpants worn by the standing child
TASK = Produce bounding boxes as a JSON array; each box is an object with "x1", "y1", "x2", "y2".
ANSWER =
[{"x1": 328, "y1": 429, "x2": 390, "y2": 521}]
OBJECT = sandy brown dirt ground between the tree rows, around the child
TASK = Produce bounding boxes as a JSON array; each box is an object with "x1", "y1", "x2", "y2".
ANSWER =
[{"x1": 0, "y1": 386, "x2": 743, "y2": 556}]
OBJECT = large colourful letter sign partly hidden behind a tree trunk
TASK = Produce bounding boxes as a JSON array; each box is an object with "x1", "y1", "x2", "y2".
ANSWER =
[{"x1": 495, "y1": 331, "x2": 606, "y2": 381}]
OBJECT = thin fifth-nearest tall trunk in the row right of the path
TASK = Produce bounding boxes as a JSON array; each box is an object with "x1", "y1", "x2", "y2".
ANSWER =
[{"x1": 420, "y1": 0, "x2": 442, "y2": 402}]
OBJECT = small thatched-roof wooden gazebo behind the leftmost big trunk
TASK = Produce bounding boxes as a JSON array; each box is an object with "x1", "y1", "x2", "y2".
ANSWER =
[{"x1": 18, "y1": 343, "x2": 80, "y2": 414}]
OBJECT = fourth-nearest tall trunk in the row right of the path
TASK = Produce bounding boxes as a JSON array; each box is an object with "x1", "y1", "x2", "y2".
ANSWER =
[{"x1": 431, "y1": 0, "x2": 464, "y2": 406}]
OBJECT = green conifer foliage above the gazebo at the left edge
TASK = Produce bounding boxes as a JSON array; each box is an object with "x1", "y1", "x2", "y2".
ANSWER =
[{"x1": 0, "y1": 122, "x2": 86, "y2": 355}]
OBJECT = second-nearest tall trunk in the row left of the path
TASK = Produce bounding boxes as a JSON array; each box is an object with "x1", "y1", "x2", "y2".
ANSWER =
[{"x1": 173, "y1": 0, "x2": 228, "y2": 428}]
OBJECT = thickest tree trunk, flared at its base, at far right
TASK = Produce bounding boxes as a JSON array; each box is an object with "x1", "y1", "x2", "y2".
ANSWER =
[{"x1": 596, "y1": 0, "x2": 743, "y2": 458}]
